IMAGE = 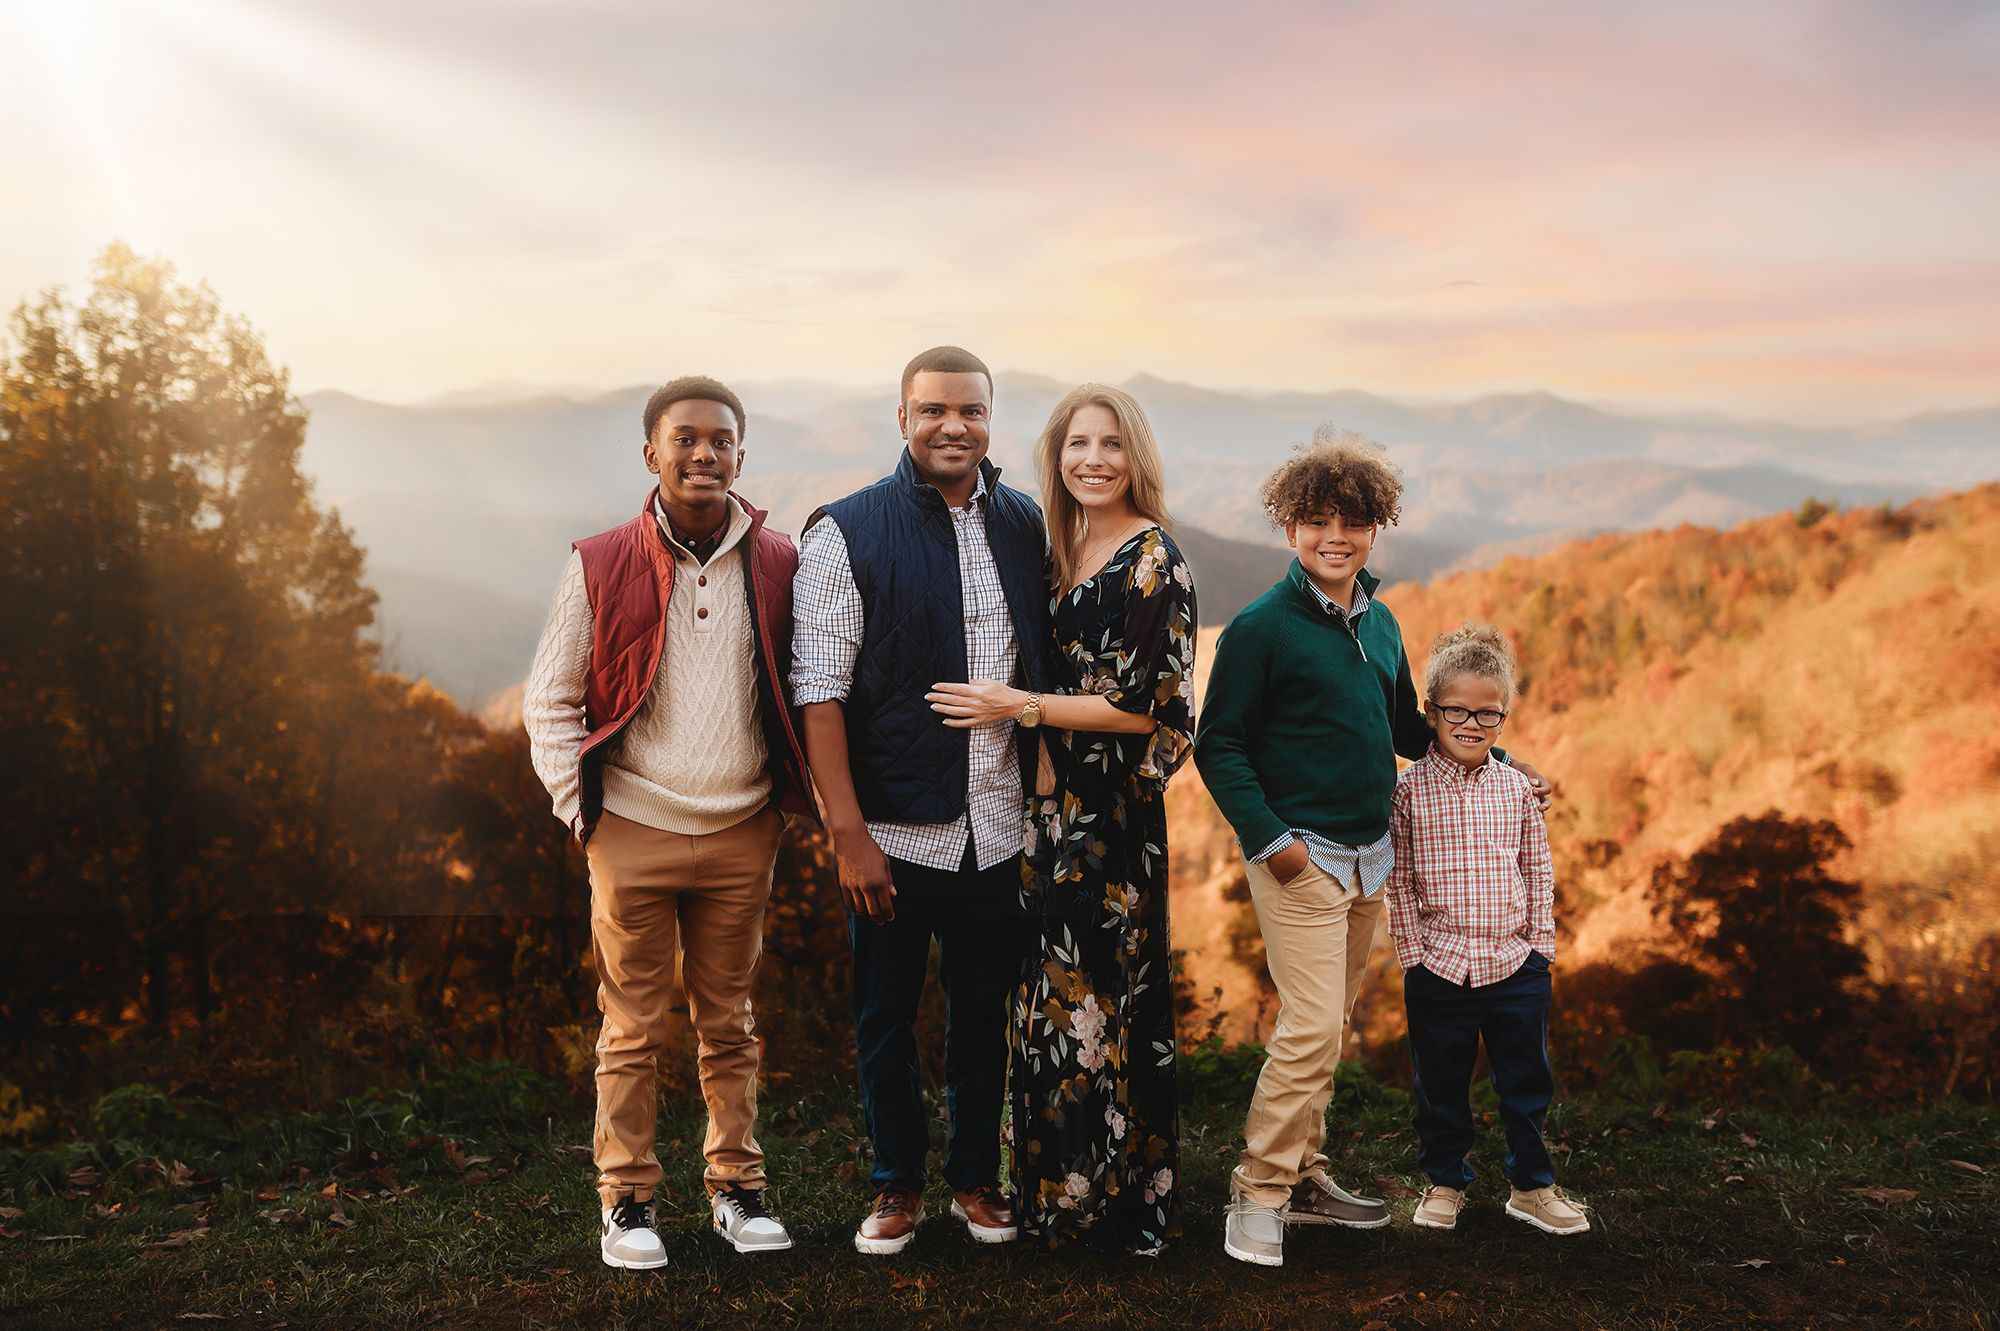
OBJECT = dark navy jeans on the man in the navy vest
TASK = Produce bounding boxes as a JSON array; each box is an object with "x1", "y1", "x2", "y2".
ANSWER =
[{"x1": 848, "y1": 855, "x2": 1028, "y2": 1193}]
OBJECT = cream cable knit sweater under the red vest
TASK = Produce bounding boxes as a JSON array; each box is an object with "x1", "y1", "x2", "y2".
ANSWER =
[{"x1": 522, "y1": 504, "x2": 770, "y2": 835}]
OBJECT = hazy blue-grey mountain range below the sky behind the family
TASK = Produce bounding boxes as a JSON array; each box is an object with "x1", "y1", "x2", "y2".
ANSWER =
[{"x1": 290, "y1": 374, "x2": 2000, "y2": 705}]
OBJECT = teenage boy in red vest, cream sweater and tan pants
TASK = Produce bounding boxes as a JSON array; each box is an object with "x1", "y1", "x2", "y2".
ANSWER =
[{"x1": 522, "y1": 376, "x2": 816, "y2": 1271}]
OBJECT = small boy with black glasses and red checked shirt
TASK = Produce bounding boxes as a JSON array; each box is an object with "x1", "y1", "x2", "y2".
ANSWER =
[{"x1": 1386, "y1": 624, "x2": 1590, "y2": 1235}]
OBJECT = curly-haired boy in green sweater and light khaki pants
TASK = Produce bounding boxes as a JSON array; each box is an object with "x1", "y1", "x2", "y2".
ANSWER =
[{"x1": 1194, "y1": 426, "x2": 1548, "y2": 1267}]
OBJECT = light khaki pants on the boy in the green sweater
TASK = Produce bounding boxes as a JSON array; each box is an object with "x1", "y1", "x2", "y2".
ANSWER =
[{"x1": 1232, "y1": 861, "x2": 1382, "y2": 1207}]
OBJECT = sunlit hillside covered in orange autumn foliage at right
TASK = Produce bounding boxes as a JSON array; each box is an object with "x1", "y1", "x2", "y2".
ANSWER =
[{"x1": 1168, "y1": 486, "x2": 2000, "y2": 1039}]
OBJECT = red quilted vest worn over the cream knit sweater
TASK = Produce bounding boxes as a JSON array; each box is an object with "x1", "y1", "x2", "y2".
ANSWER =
[{"x1": 576, "y1": 494, "x2": 820, "y2": 837}]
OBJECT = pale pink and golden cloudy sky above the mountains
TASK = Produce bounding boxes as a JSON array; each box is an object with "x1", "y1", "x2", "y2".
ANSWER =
[{"x1": 0, "y1": 0, "x2": 2000, "y2": 424}]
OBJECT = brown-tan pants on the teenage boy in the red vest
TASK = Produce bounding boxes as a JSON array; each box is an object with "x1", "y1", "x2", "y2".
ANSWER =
[{"x1": 586, "y1": 805, "x2": 784, "y2": 1205}]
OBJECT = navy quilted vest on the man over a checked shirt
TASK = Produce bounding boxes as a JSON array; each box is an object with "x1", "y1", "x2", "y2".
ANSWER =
[{"x1": 806, "y1": 450, "x2": 1050, "y2": 823}]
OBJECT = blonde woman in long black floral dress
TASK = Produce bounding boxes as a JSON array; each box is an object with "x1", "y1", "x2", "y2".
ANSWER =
[{"x1": 930, "y1": 384, "x2": 1196, "y2": 1255}]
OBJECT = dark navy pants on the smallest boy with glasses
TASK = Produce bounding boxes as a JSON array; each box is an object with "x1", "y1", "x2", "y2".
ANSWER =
[{"x1": 1402, "y1": 951, "x2": 1556, "y2": 1191}]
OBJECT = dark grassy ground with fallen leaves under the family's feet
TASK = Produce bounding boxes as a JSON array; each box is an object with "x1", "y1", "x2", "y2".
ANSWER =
[{"x1": 0, "y1": 1093, "x2": 2000, "y2": 1331}]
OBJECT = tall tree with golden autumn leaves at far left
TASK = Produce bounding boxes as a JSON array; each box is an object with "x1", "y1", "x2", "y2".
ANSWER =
[{"x1": 0, "y1": 246, "x2": 374, "y2": 1023}]
